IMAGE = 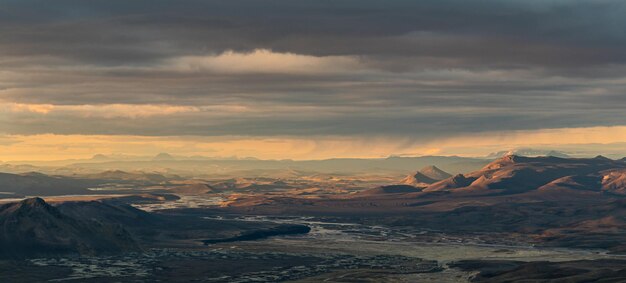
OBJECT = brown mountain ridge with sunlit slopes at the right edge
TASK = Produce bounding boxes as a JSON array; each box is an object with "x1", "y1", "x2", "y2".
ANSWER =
[{"x1": 424, "y1": 155, "x2": 626, "y2": 194}]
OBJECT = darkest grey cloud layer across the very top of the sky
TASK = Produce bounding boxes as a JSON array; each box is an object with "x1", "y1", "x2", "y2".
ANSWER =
[{"x1": 0, "y1": 0, "x2": 626, "y2": 67}]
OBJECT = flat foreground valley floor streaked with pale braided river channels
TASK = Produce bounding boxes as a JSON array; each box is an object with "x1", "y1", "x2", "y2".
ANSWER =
[{"x1": 0, "y1": 215, "x2": 626, "y2": 282}]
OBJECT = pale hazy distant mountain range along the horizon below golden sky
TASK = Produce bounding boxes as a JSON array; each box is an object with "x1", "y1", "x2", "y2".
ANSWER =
[{"x1": 6, "y1": 148, "x2": 620, "y2": 180}]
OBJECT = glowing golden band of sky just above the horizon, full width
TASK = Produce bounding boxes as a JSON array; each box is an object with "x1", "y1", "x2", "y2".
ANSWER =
[{"x1": 0, "y1": 126, "x2": 626, "y2": 161}]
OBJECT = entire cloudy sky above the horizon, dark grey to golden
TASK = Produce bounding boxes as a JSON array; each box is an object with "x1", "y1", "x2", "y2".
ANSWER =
[{"x1": 0, "y1": 0, "x2": 626, "y2": 161}]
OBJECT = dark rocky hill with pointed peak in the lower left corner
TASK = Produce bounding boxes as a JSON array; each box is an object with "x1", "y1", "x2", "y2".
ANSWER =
[{"x1": 0, "y1": 198, "x2": 139, "y2": 257}]
